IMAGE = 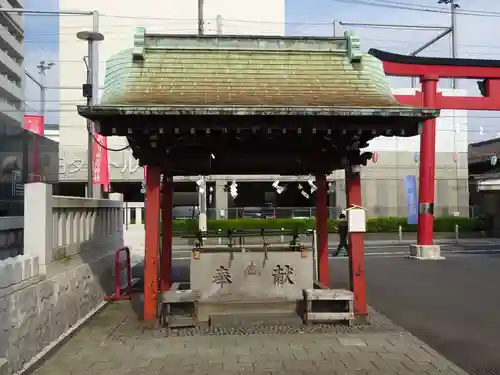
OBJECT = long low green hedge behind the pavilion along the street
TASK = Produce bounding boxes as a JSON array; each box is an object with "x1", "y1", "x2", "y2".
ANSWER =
[{"x1": 166, "y1": 217, "x2": 491, "y2": 234}]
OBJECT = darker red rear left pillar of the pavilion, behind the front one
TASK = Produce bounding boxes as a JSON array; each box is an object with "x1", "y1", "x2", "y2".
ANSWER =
[{"x1": 160, "y1": 175, "x2": 174, "y2": 292}]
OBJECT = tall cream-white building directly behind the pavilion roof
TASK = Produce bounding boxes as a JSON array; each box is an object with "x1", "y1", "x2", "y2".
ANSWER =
[{"x1": 57, "y1": 0, "x2": 285, "y2": 180}]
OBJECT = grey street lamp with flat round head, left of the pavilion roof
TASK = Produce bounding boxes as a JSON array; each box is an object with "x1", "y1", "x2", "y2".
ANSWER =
[{"x1": 76, "y1": 31, "x2": 104, "y2": 198}]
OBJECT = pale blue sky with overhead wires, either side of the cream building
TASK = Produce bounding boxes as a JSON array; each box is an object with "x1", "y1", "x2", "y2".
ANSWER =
[{"x1": 25, "y1": 0, "x2": 500, "y2": 141}]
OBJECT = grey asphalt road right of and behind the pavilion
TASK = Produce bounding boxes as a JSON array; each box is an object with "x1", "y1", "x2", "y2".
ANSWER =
[{"x1": 134, "y1": 240, "x2": 500, "y2": 375}]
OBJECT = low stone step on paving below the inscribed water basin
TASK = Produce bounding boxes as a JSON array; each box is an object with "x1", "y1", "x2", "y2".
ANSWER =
[{"x1": 209, "y1": 313, "x2": 303, "y2": 329}]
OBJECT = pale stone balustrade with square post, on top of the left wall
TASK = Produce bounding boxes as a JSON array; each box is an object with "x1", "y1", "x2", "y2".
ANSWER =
[{"x1": 0, "y1": 183, "x2": 123, "y2": 288}]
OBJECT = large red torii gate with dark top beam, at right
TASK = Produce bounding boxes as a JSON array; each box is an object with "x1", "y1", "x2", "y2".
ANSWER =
[{"x1": 368, "y1": 49, "x2": 500, "y2": 246}]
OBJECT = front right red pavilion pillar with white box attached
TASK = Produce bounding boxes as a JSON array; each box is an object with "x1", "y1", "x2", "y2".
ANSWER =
[{"x1": 346, "y1": 170, "x2": 368, "y2": 318}]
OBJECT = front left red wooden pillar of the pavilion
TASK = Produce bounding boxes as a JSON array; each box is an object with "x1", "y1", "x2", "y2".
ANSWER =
[{"x1": 144, "y1": 167, "x2": 161, "y2": 322}]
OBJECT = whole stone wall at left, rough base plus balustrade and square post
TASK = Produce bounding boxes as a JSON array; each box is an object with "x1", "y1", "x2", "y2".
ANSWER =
[{"x1": 0, "y1": 183, "x2": 123, "y2": 375}]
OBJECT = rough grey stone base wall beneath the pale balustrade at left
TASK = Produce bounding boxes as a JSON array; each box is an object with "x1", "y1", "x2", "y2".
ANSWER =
[{"x1": 0, "y1": 250, "x2": 114, "y2": 374}]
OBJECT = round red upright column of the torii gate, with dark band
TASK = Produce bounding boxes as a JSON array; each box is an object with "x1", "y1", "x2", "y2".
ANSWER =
[{"x1": 417, "y1": 76, "x2": 439, "y2": 245}]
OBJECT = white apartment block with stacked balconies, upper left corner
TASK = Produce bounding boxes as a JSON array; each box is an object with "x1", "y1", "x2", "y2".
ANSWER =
[{"x1": 0, "y1": 0, "x2": 24, "y2": 126}]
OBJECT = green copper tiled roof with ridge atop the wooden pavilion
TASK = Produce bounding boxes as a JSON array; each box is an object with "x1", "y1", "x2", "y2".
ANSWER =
[{"x1": 101, "y1": 28, "x2": 401, "y2": 108}]
